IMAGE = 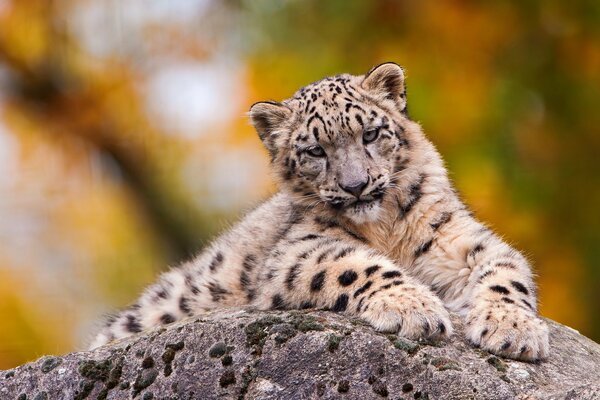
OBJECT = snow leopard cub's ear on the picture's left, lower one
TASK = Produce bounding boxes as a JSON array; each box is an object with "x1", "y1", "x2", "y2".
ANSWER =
[{"x1": 248, "y1": 101, "x2": 292, "y2": 153}]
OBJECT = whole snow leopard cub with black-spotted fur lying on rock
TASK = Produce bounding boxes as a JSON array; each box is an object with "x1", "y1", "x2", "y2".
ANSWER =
[{"x1": 91, "y1": 63, "x2": 548, "y2": 360}]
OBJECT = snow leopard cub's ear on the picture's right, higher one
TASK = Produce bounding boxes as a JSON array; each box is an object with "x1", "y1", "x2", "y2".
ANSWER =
[{"x1": 361, "y1": 62, "x2": 408, "y2": 114}]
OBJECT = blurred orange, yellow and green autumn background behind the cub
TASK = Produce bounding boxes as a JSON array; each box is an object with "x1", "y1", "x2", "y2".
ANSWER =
[{"x1": 0, "y1": 0, "x2": 600, "y2": 369}]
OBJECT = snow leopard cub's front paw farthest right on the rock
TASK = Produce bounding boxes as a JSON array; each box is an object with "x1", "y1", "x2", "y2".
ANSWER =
[{"x1": 465, "y1": 306, "x2": 550, "y2": 361}]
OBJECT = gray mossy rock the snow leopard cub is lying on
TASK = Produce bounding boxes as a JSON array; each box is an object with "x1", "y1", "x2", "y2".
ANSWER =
[{"x1": 0, "y1": 310, "x2": 600, "y2": 400}]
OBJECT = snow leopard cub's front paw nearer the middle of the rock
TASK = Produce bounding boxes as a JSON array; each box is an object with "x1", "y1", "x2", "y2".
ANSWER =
[{"x1": 360, "y1": 285, "x2": 453, "y2": 339}]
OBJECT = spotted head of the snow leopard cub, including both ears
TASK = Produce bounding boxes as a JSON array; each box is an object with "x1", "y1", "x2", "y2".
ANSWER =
[{"x1": 250, "y1": 63, "x2": 407, "y2": 223}]
